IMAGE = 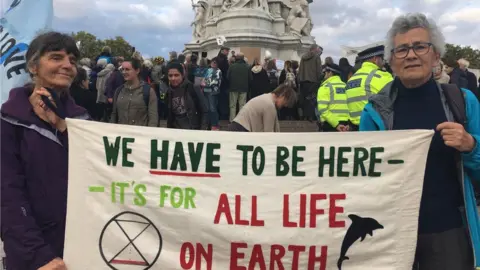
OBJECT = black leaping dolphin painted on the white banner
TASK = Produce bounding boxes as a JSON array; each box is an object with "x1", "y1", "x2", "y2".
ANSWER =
[{"x1": 337, "y1": 214, "x2": 383, "y2": 270}]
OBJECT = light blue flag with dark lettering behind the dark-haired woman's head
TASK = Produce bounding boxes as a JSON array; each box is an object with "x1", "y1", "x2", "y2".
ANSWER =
[{"x1": 0, "y1": 0, "x2": 53, "y2": 104}]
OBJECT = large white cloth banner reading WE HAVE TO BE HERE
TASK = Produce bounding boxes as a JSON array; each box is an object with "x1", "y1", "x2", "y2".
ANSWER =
[{"x1": 64, "y1": 119, "x2": 433, "y2": 270}]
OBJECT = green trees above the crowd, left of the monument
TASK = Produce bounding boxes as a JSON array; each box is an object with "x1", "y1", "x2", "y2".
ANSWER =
[{"x1": 72, "y1": 31, "x2": 133, "y2": 59}]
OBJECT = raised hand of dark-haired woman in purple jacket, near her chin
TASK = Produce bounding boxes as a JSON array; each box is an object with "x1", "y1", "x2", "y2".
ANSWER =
[{"x1": 29, "y1": 87, "x2": 66, "y2": 132}]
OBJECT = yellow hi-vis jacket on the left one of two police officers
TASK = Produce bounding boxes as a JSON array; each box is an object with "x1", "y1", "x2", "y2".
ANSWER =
[{"x1": 317, "y1": 76, "x2": 349, "y2": 128}]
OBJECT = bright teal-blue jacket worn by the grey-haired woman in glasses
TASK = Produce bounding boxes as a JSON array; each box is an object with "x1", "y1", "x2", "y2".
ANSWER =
[{"x1": 360, "y1": 79, "x2": 480, "y2": 269}]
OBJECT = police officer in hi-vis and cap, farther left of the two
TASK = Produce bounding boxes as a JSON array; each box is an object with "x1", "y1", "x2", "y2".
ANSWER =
[{"x1": 317, "y1": 63, "x2": 350, "y2": 132}]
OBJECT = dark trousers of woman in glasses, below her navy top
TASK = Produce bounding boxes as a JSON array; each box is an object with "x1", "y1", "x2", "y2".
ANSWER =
[{"x1": 412, "y1": 228, "x2": 474, "y2": 270}]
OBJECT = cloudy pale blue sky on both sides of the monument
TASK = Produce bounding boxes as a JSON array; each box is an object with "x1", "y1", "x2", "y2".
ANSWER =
[{"x1": 0, "y1": 0, "x2": 480, "y2": 59}]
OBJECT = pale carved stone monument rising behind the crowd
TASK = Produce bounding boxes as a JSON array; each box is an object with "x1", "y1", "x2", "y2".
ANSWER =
[{"x1": 185, "y1": 0, "x2": 315, "y2": 62}]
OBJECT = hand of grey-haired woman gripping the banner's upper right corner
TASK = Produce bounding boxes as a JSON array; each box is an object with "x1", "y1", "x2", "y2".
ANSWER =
[{"x1": 437, "y1": 122, "x2": 475, "y2": 153}]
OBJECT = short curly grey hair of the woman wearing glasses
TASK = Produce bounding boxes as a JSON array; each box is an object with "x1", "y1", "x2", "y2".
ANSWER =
[{"x1": 385, "y1": 13, "x2": 446, "y2": 62}]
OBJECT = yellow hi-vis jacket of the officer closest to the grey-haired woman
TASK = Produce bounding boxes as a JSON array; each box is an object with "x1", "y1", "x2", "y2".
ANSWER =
[{"x1": 346, "y1": 62, "x2": 393, "y2": 126}]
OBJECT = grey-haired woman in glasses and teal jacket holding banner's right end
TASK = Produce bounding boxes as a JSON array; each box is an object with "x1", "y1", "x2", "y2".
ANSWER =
[{"x1": 360, "y1": 13, "x2": 480, "y2": 270}]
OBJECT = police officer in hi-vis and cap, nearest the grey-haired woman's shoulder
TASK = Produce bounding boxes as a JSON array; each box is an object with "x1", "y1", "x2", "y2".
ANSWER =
[{"x1": 346, "y1": 45, "x2": 393, "y2": 131}]
